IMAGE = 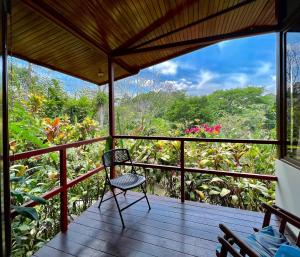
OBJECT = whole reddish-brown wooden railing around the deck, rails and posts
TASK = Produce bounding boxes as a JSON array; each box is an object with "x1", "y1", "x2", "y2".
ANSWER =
[{"x1": 10, "y1": 135, "x2": 279, "y2": 232}]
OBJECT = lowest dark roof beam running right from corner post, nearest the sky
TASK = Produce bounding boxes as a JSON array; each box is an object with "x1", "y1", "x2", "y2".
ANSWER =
[{"x1": 115, "y1": 26, "x2": 279, "y2": 57}]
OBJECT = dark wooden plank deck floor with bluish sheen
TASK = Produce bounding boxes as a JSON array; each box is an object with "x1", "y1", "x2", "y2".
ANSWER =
[{"x1": 34, "y1": 192, "x2": 270, "y2": 257}]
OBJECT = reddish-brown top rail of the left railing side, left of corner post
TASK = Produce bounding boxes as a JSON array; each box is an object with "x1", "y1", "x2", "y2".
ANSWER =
[{"x1": 9, "y1": 137, "x2": 108, "y2": 161}]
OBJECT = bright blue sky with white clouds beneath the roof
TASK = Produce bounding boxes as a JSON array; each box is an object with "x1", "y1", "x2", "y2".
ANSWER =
[{"x1": 13, "y1": 34, "x2": 276, "y2": 95}]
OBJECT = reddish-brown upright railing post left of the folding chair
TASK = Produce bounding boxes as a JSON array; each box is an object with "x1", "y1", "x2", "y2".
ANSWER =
[{"x1": 59, "y1": 148, "x2": 68, "y2": 232}]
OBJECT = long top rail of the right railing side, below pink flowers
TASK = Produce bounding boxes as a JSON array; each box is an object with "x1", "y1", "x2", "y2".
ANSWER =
[{"x1": 114, "y1": 135, "x2": 280, "y2": 145}]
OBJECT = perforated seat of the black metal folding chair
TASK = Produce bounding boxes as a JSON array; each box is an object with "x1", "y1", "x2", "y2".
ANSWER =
[{"x1": 110, "y1": 173, "x2": 146, "y2": 190}]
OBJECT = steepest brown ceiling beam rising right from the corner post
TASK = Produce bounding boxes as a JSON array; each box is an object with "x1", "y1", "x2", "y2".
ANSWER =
[{"x1": 113, "y1": 0, "x2": 199, "y2": 54}]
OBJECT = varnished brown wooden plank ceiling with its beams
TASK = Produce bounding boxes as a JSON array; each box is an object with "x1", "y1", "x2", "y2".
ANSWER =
[{"x1": 9, "y1": 0, "x2": 278, "y2": 85}]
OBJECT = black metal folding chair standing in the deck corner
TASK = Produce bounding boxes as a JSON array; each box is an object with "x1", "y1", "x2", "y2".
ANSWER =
[{"x1": 98, "y1": 149, "x2": 151, "y2": 228}]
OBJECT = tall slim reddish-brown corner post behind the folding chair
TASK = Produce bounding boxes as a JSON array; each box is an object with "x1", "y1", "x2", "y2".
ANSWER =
[{"x1": 108, "y1": 57, "x2": 116, "y2": 178}]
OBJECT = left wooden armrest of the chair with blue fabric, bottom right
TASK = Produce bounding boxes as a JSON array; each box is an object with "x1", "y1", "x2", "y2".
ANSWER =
[{"x1": 219, "y1": 224, "x2": 259, "y2": 257}]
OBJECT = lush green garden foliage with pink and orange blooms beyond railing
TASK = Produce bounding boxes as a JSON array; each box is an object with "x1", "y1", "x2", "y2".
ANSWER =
[{"x1": 9, "y1": 62, "x2": 276, "y2": 256}]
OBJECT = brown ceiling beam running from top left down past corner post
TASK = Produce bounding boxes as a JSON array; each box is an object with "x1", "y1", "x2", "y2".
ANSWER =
[{"x1": 21, "y1": 0, "x2": 136, "y2": 73}]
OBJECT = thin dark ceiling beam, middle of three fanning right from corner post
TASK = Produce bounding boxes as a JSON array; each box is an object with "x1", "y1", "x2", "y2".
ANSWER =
[{"x1": 120, "y1": 0, "x2": 255, "y2": 49}]
